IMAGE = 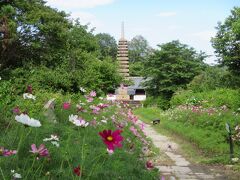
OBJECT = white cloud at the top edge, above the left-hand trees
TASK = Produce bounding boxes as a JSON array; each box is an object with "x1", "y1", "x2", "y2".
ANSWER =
[{"x1": 47, "y1": 0, "x2": 114, "y2": 10}]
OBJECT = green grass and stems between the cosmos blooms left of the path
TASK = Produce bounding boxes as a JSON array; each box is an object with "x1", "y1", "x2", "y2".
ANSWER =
[{"x1": 0, "y1": 93, "x2": 159, "y2": 180}]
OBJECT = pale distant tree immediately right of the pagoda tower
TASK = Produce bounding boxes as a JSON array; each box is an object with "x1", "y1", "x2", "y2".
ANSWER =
[{"x1": 128, "y1": 35, "x2": 152, "y2": 63}]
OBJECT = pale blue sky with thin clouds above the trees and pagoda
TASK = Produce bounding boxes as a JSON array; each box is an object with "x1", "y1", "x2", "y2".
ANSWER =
[{"x1": 46, "y1": 0, "x2": 240, "y2": 64}]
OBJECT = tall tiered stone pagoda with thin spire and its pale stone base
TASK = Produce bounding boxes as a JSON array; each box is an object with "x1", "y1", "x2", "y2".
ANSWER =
[{"x1": 116, "y1": 23, "x2": 130, "y2": 101}]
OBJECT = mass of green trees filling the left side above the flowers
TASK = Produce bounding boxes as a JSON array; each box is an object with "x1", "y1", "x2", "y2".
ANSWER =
[{"x1": 0, "y1": 0, "x2": 121, "y2": 92}]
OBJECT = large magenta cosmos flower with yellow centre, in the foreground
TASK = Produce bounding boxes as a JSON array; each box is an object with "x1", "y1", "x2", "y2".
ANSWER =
[{"x1": 99, "y1": 129, "x2": 123, "y2": 151}]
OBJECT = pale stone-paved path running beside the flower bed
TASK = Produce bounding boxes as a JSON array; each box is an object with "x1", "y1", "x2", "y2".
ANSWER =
[{"x1": 141, "y1": 121, "x2": 228, "y2": 180}]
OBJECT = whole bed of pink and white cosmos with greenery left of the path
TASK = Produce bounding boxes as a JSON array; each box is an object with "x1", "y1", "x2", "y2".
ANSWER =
[{"x1": 0, "y1": 81, "x2": 159, "y2": 179}]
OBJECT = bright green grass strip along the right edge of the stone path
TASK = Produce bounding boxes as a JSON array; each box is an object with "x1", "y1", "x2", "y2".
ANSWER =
[{"x1": 134, "y1": 108, "x2": 240, "y2": 164}]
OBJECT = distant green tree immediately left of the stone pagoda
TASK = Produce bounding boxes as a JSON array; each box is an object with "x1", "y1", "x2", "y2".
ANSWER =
[{"x1": 96, "y1": 33, "x2": 117, "y2": 59}]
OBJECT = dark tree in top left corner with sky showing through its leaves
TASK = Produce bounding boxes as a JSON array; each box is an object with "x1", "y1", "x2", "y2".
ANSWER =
[{"x1": 0, "y1": 0, "x2": 72, "y2": 67}]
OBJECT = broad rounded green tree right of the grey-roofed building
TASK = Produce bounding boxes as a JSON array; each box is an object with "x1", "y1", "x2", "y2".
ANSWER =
[{"x1": 144, "y1": 41, "x2": 206, "y2": 98}]
